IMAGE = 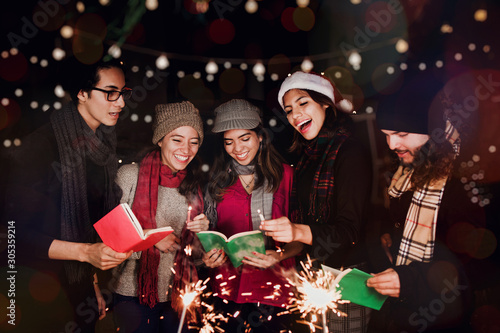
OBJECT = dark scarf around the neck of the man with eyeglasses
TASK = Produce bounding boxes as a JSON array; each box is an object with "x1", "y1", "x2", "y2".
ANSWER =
[{"x1": 50, "y1": 103, "x2": 119, "y2": 284}]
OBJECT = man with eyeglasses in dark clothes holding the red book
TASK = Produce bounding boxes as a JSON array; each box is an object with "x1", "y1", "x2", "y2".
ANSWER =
[{"x1": 6, "y1": 61, "x2": 132, "y2": 332}]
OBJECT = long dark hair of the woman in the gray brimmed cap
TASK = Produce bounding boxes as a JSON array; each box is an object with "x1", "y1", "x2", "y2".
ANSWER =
[{"x1": 208, "y1": 125, "x2": 286, "y2": 202}]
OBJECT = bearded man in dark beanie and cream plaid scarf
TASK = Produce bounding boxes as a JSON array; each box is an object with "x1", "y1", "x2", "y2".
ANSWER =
[{"x1": 367, "y1": 74, "x2": 485, "y2": 332}]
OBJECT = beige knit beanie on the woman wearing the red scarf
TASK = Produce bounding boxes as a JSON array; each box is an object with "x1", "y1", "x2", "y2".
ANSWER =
[{"x1": 153, "y1": 101, "x2": 203, "y2": 146}]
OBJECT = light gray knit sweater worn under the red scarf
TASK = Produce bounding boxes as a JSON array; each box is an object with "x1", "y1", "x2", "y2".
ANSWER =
[{"x1": 113, "y1": 164, "x2": 188, "y2": 302}]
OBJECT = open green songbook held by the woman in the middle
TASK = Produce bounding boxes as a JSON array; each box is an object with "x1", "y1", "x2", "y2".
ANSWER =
[{"x1": 196, "y1": 230, "x2": 266, "y2": 267}]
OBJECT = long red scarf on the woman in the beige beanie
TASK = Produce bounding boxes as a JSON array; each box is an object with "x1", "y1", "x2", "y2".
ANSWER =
[{"x1": 132, "y1": 150, "x2": 186, "y2": 308}]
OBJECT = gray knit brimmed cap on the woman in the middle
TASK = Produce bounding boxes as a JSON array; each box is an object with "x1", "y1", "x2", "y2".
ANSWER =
[{"x1": 212, "y1": 99, "x2": 262, "y2": 133}]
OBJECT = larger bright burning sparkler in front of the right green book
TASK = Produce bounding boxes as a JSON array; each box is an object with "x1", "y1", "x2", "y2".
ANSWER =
[{"x1": 289, "y1": 258, "x2": 347, "y2": 333}]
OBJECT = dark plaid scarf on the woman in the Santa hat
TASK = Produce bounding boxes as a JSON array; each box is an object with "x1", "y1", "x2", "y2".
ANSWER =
[{"x1": 290, "y1": 123, "x2": 351, "y2": 223}]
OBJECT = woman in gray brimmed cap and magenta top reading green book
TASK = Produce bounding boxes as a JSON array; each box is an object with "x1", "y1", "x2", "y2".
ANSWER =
[{"x1": 203, "y1": 99, "x2": 300, "y2": 332}]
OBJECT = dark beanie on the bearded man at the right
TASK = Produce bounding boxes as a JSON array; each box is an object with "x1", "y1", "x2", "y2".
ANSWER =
[{"x1": 376, "y1": 73, "x2": 443, "y2": 134}]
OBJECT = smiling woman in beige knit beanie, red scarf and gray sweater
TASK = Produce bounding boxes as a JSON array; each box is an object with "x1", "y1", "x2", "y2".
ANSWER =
[{"x1": 114, "y1": 102, "x2": 209, "y2": 333}]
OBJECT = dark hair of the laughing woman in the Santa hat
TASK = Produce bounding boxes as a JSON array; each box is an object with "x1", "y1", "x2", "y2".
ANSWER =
[{"x1": 289, "y1": 89, "x2": 354, "y2": 154}]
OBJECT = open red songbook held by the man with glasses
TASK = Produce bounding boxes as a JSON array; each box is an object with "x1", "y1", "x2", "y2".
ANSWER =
[{"x1": 94, "y1": 203, "x2": 174, "y2": 252}]
